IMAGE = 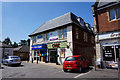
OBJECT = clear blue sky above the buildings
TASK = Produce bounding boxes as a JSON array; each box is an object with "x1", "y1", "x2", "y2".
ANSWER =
[{"x1": 2, "y1": 2, "x2": 94, "y2": 42}]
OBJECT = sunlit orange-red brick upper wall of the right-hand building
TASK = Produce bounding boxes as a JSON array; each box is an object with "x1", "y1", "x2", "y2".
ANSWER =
[{"x1": 98, "y1": 3, "x2": 120, "y2": 32}]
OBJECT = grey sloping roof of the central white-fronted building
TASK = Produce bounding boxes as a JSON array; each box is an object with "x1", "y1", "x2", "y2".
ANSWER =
[{"x1": 29, "y1": 12, "x2": 94, "y2": 36}]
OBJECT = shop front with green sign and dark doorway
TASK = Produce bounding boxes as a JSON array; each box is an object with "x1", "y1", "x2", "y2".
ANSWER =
[{"x1": 47, "y1": 41, "x2": 67, "y2": 64}]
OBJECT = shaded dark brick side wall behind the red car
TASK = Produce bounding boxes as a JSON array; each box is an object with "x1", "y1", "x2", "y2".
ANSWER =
[{"x1": 72, "y1": 25, "x2": 95, "y2": 64}]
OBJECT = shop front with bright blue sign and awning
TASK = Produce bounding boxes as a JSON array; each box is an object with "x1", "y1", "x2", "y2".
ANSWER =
[{"x1": 32, "y1": 44, "x2": 47, "y2": 62}]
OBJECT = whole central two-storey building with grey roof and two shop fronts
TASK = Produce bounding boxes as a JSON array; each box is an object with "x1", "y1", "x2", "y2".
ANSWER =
[{"x1": 29, "y1": 12, "x2": 95, "y2": 64}]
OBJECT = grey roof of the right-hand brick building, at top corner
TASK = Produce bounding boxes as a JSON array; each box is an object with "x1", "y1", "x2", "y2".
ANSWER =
[{"x1": 94, "y1": 0, "x2": 120, "y2": 9}]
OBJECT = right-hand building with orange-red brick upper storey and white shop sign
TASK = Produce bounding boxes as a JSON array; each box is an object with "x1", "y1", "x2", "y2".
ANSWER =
[{"x1": 92, "y1": 0, "x2": 120, "y2": 66}]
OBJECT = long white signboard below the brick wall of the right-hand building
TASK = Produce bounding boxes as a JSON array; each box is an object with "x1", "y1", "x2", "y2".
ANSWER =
[{"x1": 99, "y1": 32, "x2": 120, "y2": 40}]
